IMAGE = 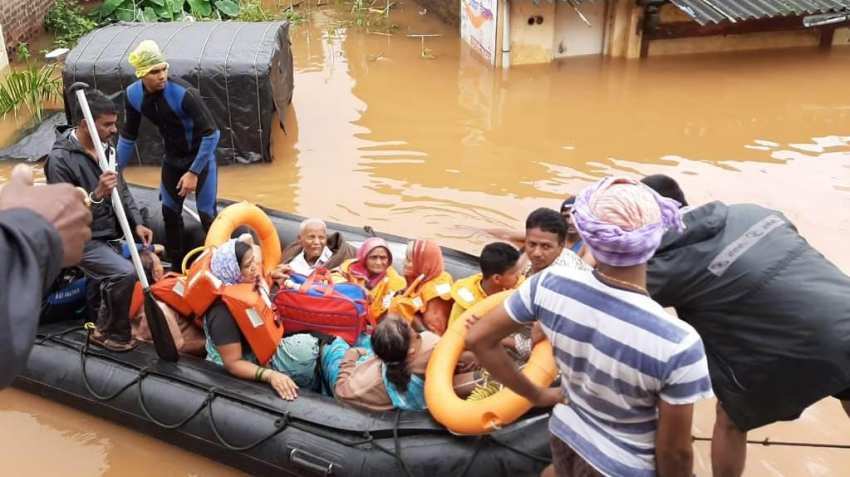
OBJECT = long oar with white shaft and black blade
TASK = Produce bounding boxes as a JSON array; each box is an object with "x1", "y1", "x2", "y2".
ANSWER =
[{"x1": 68, "y1": 82, "x2": 180, "y2": 362}]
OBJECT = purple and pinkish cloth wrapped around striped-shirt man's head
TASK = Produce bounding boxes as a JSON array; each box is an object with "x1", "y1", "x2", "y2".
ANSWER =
[{"x1": 573, "y1": 177, "x2": 684, "y2": 267}]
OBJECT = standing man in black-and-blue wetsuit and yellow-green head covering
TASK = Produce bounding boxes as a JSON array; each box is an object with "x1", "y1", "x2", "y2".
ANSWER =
[{"x1": 118, "y1": 40, "x2": 219, "y2": 263}]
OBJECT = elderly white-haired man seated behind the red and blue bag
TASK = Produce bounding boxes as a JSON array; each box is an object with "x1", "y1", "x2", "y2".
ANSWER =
[{"x1": 283, "y1": 219, "x2": 357, "y2": 275}]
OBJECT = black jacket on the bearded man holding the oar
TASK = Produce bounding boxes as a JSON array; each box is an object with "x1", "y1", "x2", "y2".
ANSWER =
[{"x1": 44, "y1": 126, "x2": 143, "y2": 240}]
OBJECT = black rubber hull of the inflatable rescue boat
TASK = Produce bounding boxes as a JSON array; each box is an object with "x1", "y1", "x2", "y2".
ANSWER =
[{"x1": 16, "y1": 187, "x2": 550, "y2": 477}]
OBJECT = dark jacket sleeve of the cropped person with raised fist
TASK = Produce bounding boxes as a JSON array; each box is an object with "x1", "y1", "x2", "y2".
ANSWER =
[{"x1": 0, "y1": 209, "x2": 62, "y2": 388}]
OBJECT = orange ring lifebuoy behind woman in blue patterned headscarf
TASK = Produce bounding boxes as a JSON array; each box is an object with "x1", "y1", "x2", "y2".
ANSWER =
[{"x1": 204, "y1": 202, "x2": 281, "y2": 274}]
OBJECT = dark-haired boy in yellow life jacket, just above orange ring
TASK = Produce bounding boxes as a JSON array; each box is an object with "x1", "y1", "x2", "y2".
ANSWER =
[{"x1": 449, "y1": 242, "x2": 522, "y2": 325}]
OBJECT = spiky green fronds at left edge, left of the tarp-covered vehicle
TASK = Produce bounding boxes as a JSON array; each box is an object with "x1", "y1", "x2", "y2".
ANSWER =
[{"x1": 0, "y1": 43, "x2": 62, "y2": 121}]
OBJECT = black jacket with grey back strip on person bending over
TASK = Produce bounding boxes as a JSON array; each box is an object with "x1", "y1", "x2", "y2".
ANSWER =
[{"x1": 647, "y1": 202, "x2": 850, "y2": 430}]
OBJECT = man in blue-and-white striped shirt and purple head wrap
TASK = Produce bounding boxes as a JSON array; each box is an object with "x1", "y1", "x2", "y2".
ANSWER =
[{"x1": 467, "y1": 178, "x2": 712, "y2": 477}]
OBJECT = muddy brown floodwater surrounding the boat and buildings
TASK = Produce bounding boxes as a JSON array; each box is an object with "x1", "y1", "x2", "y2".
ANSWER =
[{"x1": 0, "y1": 1, "x2": 850, "y2": 477}]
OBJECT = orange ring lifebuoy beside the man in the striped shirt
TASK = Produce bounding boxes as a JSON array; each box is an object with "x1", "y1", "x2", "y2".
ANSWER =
[{"x1": 425, "y1": 290, "x2": 558, "y2": 434}]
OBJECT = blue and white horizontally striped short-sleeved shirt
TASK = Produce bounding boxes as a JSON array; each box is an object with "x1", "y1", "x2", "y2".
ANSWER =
[{"x1": 505, "y1": 267, "x2": 713, "y2": 477}]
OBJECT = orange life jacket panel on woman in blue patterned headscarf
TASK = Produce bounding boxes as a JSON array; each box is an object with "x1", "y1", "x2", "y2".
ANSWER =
[{"x1": 220, "y1": 283, "x2": 283, "y2": 365}]
